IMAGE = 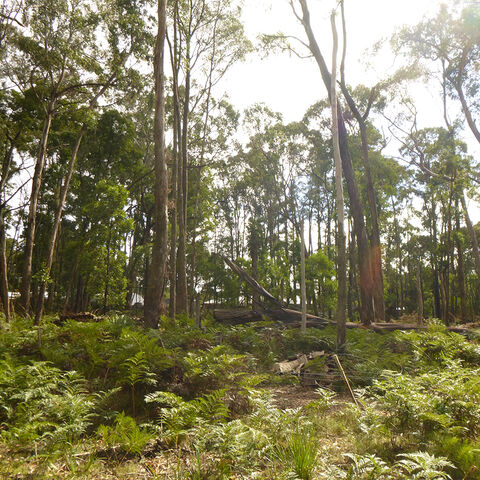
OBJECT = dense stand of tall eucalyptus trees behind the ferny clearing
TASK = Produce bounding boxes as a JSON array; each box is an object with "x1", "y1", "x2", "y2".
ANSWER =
[{"x1": 0, "y1": 0, "x2": 480, "y2": 324}]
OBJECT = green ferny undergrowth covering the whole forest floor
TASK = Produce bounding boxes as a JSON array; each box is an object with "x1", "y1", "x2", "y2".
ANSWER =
[{"x1": 0, "y1": 315, "x2": 480, "y2": 480}]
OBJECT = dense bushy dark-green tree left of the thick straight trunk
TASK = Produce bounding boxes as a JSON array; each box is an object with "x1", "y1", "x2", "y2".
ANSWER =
[{"x1": 44, "y1": 109, "x2": 143, "y2": 311}]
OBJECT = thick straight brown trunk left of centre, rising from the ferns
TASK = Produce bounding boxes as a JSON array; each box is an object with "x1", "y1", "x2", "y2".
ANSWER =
[{"x1": 144, "y1": 0, "x2": 168, "y2": 328}]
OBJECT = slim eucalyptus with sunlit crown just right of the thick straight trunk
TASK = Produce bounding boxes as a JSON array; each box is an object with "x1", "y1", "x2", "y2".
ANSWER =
[{"x1": 169, "y1": 0, "x2": 251, "y2": 312}]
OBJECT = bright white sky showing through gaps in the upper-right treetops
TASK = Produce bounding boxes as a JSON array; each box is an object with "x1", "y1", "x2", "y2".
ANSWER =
[{"x1": 221, "y1": 0, "x2": 480, "y2": 221}]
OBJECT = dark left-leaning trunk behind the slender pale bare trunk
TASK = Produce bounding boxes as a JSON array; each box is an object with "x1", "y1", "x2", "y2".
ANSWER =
[{"x1": 298, "y1": 0, "x2": 374, "y2": 325}]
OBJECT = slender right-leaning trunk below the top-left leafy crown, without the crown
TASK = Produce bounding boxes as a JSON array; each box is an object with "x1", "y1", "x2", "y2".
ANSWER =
[{"x1": 20, "y1": 107, "x2": 55, "y2": 314}]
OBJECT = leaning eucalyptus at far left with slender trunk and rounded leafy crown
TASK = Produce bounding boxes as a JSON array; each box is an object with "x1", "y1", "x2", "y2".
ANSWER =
[{"x1": 2, "y1": 0, "x2": 108, "y2": 311}]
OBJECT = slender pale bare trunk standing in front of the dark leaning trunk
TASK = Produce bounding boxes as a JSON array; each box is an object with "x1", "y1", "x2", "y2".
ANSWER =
[{"x1": 330, "y1": 13, "x2": 347, "y2": 350}]
